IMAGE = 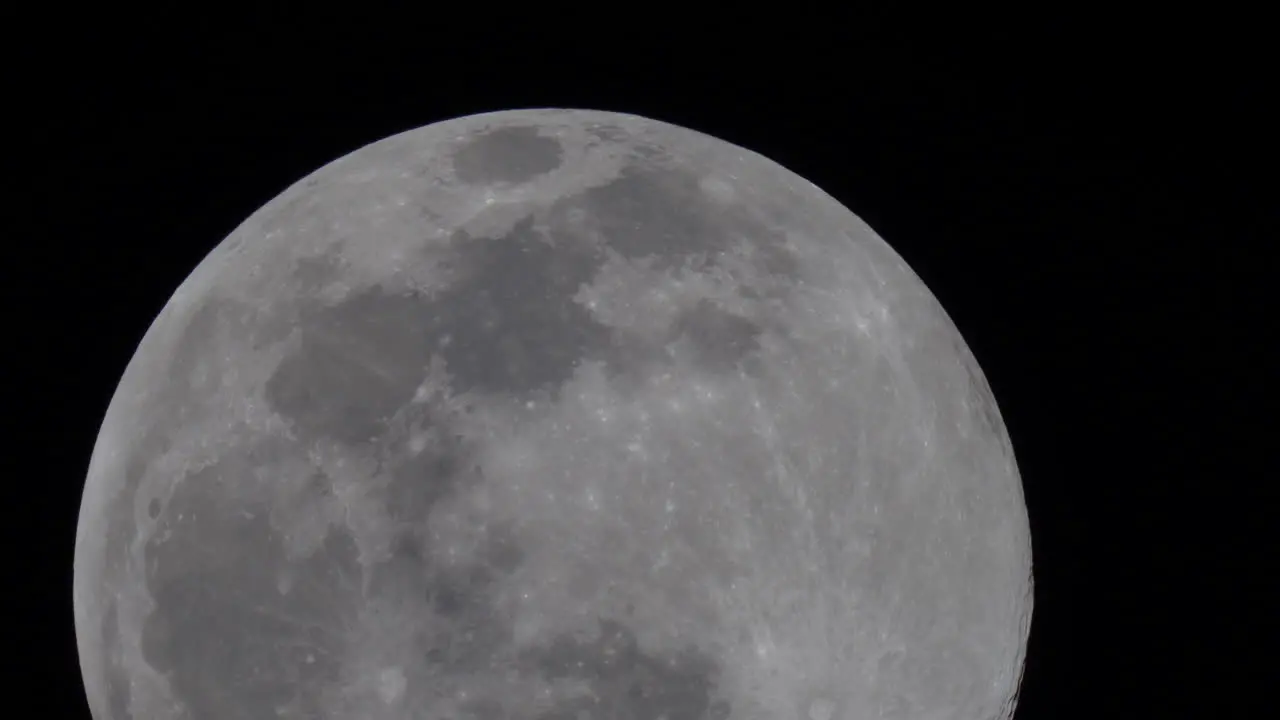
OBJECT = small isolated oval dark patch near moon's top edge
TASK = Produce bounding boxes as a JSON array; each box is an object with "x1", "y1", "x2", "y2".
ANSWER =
[{"x1": 453, "y1": 127, "x2": 564, "y2": 184}]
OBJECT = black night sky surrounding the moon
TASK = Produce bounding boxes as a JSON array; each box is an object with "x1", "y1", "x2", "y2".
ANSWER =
[{"x1": 12, "y1": 16, "x2": 1276, "y2": 720}]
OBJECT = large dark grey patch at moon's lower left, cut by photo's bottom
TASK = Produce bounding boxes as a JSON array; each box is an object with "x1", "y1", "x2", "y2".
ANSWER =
[{"x1": 142, "y1": 453, "x2": 360, "y2": 720}]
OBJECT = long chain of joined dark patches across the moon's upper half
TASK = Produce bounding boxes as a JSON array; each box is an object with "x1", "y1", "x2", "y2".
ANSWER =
[{"x1": 265, "y1": 155, "x2": 777, "y2": 445}]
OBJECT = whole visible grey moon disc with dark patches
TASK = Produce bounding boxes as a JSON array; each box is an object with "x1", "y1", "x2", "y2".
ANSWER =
[{"x1": 74, "y1": 110, "x2": 1032, "y2": 720}]
